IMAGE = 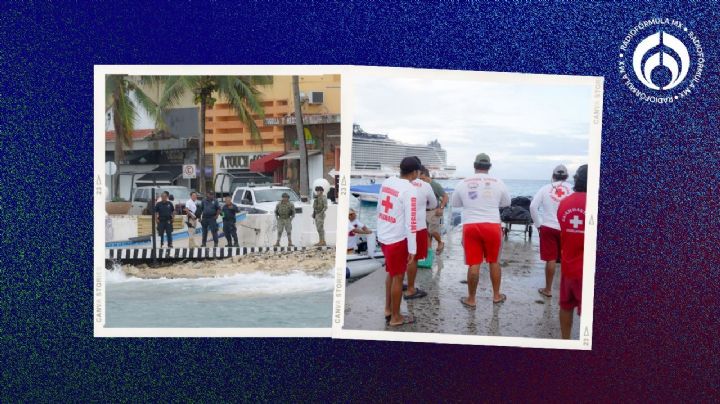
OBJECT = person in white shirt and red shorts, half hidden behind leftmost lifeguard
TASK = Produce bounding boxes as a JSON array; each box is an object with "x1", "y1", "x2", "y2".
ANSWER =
[{"x1": 405, "y1": 161, "x2": 437, "y2": 300}]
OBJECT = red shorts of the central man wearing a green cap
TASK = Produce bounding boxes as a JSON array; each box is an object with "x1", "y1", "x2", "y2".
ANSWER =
[{"x1": 463, "y1": 223, "x2": 502, "y2": 265}]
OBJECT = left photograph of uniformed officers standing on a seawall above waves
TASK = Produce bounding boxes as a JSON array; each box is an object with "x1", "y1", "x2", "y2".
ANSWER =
[{"x1": 95, "y1": 70, "x2": 341, "y2": 329}]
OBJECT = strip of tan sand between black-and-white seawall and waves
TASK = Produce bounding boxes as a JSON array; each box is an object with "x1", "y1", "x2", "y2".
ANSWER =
[{"x1": 122, "y1": 249, "x2": 335, "y2": 279}]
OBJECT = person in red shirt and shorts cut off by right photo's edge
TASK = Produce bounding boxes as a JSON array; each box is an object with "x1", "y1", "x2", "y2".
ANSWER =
[{"x1": 557, "y1": 164, "x2": 587, "y2": 339}]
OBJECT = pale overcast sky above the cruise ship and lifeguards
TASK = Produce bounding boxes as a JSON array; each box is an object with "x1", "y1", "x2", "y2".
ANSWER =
[{"x1": 354, "y1": 77, "x2": 592, "y2": 179}]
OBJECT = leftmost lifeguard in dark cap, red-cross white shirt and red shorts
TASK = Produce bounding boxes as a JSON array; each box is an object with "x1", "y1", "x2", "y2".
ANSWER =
[{"x1": 377, "y1": 157, "x2": 420, "y2": 327}]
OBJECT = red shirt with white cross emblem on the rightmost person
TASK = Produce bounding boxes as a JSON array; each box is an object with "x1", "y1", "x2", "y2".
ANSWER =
[{"x1": 557, "y1": 192, "x2": 587, "y2": 279}]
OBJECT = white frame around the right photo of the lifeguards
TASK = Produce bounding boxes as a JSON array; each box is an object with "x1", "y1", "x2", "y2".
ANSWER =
[{"x1": 332, "y1": 66, "x2": 604, "y2": 350}]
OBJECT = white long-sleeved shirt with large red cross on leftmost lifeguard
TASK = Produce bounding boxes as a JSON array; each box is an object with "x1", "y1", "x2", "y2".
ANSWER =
[{"x1": 377, "y1": 177, "x2": 418, "y2": 254}]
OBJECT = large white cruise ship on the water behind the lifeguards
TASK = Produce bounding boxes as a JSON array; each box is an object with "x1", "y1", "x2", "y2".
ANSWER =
[{"x1": 350, "y1": 124, "x2": 455, "y2": 179}]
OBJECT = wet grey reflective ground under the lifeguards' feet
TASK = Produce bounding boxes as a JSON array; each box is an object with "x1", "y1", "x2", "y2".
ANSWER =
[{"x1": 343, "y1": 227, "x2": 580, "y2": 339}]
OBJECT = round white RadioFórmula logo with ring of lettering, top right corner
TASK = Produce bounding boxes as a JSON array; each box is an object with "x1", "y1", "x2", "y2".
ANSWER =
[{"x1": 618, "y1": 18, "x2": 705, "y2": 104}]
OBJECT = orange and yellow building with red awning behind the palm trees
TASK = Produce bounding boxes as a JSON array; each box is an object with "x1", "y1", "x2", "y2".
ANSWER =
[{"x1": 205, "y1": 75, "x2": 340, "y2": 190}]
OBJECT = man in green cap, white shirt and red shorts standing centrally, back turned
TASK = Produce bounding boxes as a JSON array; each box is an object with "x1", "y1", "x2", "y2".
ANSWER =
[{"x1": 452, "y1": 153, "x2": 510, "y2": 308}]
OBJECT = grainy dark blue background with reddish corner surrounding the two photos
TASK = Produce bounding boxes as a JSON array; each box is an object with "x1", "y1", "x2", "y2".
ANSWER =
[{"x1": 0, "y1": 1, "x2": 720, "y2": 401}]
